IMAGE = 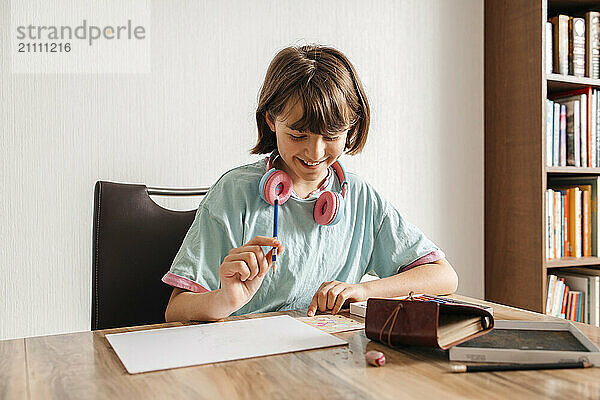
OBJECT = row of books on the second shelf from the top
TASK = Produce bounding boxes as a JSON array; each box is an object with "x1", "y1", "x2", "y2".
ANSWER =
[{"x1": 546, "y1": 87, "x2": 600, "y2": 168}]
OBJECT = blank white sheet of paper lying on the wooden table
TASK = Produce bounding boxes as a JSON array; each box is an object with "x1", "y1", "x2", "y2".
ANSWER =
[{"x1": 106, "y1": 315, "x2": 348, "y2": 374}]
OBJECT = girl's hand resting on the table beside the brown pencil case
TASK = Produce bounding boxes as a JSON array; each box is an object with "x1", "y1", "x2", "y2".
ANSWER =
[{"x1": 307, "y1": 281, "x2": 367, "y2": 317}]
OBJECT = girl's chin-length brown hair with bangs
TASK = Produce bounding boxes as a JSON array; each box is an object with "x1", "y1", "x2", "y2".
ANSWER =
[{"x1": 251, "y1": 45, "x2": 370, "y2": 154}]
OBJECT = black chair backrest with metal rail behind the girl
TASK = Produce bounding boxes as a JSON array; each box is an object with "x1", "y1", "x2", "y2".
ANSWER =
[{"x1": 91, "y1": 181, "x2": 208, "y2": 330}]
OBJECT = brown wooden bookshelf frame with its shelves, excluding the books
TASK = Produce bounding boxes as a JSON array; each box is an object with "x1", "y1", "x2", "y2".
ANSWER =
[{"x1": 484, "y1": 0, "x2": 600, "y2": 312}]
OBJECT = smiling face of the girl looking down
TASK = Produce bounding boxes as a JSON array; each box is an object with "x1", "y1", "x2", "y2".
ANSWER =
[{"x1": 266, "y1": 102, "x2": 348, "y2": 197}]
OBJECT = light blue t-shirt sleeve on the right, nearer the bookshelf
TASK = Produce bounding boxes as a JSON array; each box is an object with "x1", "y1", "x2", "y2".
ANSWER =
[{"x1": 367, "y1": 202, "x2": 445, "y2": 278}]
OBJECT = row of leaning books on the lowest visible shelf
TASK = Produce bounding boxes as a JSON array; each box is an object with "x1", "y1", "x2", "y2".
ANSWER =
[{"x1": 546, "y1": 268, "x2": 600, "y2": 326}]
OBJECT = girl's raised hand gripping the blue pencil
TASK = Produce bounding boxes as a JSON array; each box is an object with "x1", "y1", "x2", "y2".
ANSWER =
[{"x1": 219, "y1": 236, "x2": 283, "y2": 311}]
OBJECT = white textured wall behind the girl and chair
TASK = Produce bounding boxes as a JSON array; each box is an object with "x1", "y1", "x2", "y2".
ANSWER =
[{"x1": 0, "y1": 0, "x2": 484, "y2": 339}]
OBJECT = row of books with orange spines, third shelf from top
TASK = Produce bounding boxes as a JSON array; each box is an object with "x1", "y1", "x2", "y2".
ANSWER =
[{"x1": 546, "y1": 176, "x2": 600, "y2": 260}]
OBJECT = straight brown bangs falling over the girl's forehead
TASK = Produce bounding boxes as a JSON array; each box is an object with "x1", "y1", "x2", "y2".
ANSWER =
[{"x1": 282, "y1": 81, "x2": 358, "y2": 136}]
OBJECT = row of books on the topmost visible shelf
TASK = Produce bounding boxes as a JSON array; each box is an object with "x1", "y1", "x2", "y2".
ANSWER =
[{"x1": 546, "y1": 11, "x2": 600, "y2": 79}]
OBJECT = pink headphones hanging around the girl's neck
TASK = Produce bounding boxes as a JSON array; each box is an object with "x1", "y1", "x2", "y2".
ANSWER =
[{"x1": 258, "y1": 152, "x2": 348, "y2": 225}]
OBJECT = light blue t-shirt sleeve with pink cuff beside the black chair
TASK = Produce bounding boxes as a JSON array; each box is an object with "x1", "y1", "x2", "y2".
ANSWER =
[{"x1": 162, "y1": 204, "x2": 237, "y2": 293}]
